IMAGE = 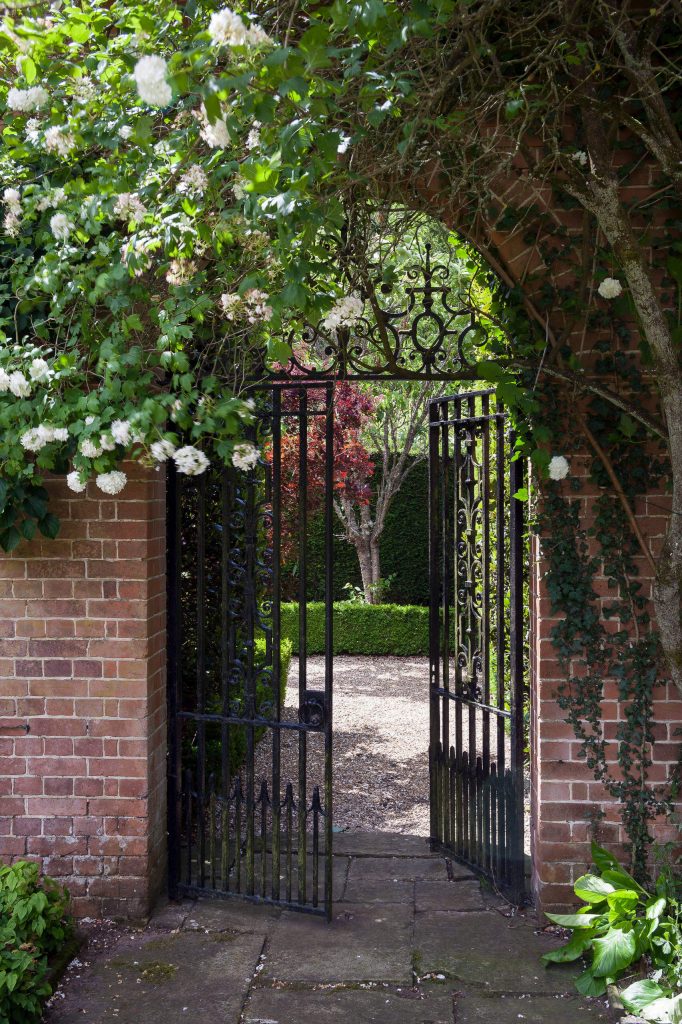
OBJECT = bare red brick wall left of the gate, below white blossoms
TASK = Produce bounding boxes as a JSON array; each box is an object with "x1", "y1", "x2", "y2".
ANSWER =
[{"x1": 0, "y1": 465, "x2": 166, "y2": 916}]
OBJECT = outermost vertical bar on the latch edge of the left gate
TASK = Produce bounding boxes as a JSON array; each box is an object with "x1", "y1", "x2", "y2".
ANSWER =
[{"x1": 325, "y1": 384, "x2": 334, "y2": 921}]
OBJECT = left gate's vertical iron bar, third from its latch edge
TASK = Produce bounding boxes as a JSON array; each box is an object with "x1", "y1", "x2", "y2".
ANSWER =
[{"x1": 270, "y1": 388, "x2": 280, "y2": 900}]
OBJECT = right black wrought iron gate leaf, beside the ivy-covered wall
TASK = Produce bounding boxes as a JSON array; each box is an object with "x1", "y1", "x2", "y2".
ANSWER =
[{"x1": 429, "y1": 391, "x2": 524, "y2": 900}]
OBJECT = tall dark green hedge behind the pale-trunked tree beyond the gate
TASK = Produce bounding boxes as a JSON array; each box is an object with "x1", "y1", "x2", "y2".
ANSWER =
[{"x1": 282, "y1": 457, "x2": 429, "y2": 605}]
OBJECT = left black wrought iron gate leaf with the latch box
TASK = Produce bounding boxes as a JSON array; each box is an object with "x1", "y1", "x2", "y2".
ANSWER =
[{"x1": 168, "y1": 382, "x2": 334, "y2": 916}]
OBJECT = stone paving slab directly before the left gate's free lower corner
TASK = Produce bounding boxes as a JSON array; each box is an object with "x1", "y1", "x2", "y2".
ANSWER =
[{"x1": 261, "y1": 904, "x2": 413, "y2": 984}]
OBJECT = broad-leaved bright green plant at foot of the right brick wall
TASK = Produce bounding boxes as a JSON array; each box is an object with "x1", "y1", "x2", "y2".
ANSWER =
[{"x1": 543, "y1": 844, "x2": 682, "y2": 1024}]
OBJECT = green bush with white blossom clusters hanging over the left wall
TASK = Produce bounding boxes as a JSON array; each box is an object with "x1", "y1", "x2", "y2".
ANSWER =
[{"x1": 0, "y1": 0, "x2": 350, "y2": 550}]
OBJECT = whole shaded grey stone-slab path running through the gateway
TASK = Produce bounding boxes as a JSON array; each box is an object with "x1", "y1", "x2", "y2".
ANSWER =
[{"x1": 44, "y1": 834, "x2": 616, "y2": 1024}]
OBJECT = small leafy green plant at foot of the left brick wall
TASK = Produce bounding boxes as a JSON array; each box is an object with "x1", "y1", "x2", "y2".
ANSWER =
[{"x1": 0, "y1": 861, "x2": 73, "y2": 1024}]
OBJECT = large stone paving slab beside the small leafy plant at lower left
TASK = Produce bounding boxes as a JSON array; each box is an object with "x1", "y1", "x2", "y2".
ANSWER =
[{"x1": 45, "y1": 932, "x2": 263, "y2": 1024}]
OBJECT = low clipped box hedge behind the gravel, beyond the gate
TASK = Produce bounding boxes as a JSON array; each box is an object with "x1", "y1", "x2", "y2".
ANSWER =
[{"x1": 282, "y1": 601, "x2": 429, "y2": 655}]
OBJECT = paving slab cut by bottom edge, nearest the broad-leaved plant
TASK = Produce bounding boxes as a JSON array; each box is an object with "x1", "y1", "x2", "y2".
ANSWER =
[{"x1": 455, "y1": 993, "x2": 617, "y2": 1024}]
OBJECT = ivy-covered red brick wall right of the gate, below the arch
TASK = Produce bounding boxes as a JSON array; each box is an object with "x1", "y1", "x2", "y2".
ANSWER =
[{"x1": 530, "y1": 455, "x2": 682, "y2": 911}]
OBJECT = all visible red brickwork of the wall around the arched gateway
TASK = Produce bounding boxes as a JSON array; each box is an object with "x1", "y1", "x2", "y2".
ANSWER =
[{"x1": 0, "y1": 188, "x2": 682, "y2": 916}]
